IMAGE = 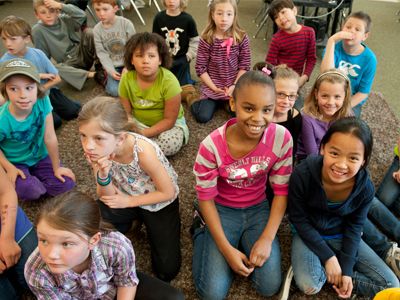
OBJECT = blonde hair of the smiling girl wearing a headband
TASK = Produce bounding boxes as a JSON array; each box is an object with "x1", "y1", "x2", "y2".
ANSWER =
[{"x1": 303, "y1": 69, "x2": 353, "y2": 121}]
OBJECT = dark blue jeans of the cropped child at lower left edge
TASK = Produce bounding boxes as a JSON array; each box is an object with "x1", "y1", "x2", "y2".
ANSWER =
[{"x1": 0, "y1": 229, "x2": 38, "y2": 300}]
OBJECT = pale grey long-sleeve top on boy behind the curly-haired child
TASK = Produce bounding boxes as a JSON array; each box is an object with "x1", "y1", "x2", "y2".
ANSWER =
[{"x1": 93, "y1": 16, "x2": 136, "y2": 74}]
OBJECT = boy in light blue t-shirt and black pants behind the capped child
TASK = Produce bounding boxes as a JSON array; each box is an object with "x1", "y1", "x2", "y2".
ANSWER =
[{"x1": 0, "y1": 16, "x2": 81, "y2": 128}]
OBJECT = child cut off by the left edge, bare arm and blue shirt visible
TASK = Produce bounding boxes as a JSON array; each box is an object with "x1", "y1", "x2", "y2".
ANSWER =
[{"x1": 0, "y1": 167, "x2": 37, "y2": 300}]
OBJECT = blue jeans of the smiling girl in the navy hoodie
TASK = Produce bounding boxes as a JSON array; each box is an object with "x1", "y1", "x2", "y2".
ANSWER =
[{"x1": 292, "y1": 234, "x2": 399, "y2": 297}]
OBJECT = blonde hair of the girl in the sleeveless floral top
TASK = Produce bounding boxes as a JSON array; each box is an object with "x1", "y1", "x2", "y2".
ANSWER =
[{"x1": 78, "y1": 97, "x2": 137, "y2": 135}]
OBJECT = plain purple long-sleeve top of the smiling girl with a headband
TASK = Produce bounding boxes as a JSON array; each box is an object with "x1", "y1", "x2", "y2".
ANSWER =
[{"x1": 296, "y1": 113, "x2": 331, "y2": 158}]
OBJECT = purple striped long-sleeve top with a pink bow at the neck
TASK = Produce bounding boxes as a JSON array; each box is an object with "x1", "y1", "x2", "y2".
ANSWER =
[{"x1": 195, "y1": 35, "x2": 250, "y2": 100}]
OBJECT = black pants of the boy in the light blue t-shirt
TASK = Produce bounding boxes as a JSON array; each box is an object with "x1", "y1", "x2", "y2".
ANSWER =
[{"x1": 49, "y1": 88, "x2": 81, "y2": 128}]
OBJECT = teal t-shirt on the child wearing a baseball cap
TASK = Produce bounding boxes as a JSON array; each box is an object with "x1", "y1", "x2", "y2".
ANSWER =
[{"x1": 0, "y1": 96, "x2": 53, "y2": 167}]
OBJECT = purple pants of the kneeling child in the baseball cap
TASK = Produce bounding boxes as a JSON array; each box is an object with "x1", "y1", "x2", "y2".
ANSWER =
[{"x1": 15, "y1": 156, "x2": 75, "y2": 201}]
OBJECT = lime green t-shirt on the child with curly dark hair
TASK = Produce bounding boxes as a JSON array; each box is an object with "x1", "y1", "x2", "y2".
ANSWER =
[{"x1": 119, "y1": 67, "x2": 183, "y2": 126}]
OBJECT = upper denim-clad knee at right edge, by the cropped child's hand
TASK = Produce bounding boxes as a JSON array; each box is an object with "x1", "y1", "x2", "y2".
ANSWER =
[{"x1": 376, "y1": 156, "x2": 400, "y2": 216}]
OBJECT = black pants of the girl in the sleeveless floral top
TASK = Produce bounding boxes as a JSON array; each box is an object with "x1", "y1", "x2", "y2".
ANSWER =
[{"x1": 97, "y1": 198, "x2": 182, "y2": 282}]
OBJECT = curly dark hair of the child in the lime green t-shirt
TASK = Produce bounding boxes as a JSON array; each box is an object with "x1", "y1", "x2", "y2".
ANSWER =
[{"x1": 124, "y1": 32, "x2": 172, "y2": 71}]
